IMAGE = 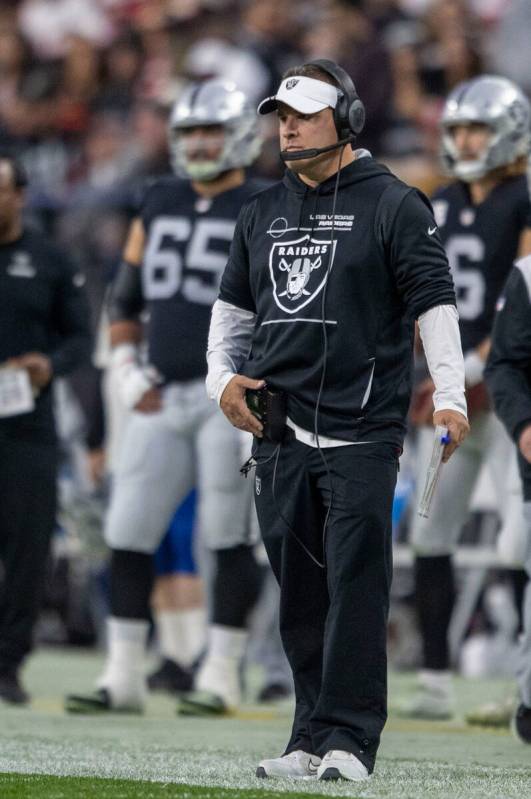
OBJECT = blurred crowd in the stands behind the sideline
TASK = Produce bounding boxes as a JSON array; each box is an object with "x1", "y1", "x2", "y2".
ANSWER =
[{"x1": 0, "y1": 0, "x2": 531, "y2": 328}]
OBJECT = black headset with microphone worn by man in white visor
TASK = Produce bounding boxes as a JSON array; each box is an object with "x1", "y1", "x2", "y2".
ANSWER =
[{"x1": 280, "y1": 58, "x2": 365, "y2": 161}]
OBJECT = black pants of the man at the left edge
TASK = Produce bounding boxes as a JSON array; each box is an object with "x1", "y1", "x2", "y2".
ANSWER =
[{"x1": 0, "y1": 430, "x2": 57, "y2": 672}]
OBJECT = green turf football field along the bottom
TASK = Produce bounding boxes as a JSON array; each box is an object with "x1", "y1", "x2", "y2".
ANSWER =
[{"x1": 0, "y1": 650, "x2": 531, "y2": 799}]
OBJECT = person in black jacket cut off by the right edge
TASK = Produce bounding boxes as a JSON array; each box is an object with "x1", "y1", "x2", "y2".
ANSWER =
[{"x1": 485, "y1": 255, "x2": 531, "y2": 744}]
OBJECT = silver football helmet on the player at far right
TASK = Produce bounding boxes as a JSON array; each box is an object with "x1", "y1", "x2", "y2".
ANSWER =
[{"x1": 441, "y1": 75, "x2": 531, "y2": 182}]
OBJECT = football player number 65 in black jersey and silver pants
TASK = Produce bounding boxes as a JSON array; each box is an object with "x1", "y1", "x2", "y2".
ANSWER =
[{"x1": 67, "y1": 81, "x2": 262, "y2": 712}]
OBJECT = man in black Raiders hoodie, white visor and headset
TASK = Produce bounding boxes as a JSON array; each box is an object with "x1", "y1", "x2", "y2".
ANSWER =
[{"x1": 207, "y1": 61, "x2": 468, "y2": 780}]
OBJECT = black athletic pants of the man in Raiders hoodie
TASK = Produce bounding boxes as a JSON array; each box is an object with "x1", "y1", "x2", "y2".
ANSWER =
[{"x1": 255, "y1": 439, "x2": 398, "y2": 771}]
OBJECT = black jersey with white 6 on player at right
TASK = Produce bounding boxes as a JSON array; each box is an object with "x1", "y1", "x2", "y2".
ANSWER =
[{"x1": 432, "y1": 175, "x2": 531, "y2": 352}]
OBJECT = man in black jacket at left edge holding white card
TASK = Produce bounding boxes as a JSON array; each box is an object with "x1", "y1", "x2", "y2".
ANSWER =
[{"x1": 0, "y1": 155, "x2": 90, "y2": 703}]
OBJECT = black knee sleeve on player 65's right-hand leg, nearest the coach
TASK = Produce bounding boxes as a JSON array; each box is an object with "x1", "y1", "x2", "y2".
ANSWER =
[{"x1": 212, "y1": 545, "x2": 264, "y2": 629}]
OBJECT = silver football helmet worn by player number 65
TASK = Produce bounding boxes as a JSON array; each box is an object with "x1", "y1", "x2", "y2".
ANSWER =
[{"x1": 169, "y1": 79, "x2": 261, "y2": 181}]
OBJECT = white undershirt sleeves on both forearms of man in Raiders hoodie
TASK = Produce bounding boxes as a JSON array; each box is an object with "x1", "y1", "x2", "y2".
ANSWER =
[{"x1": 206, "y1": 300, "x2": 466, "y2": 416}]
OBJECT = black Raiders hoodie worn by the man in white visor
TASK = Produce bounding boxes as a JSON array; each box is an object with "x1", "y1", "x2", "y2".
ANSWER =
[{"x1": 219, "y1": 157, "x2": 455, "y2": 444}]
